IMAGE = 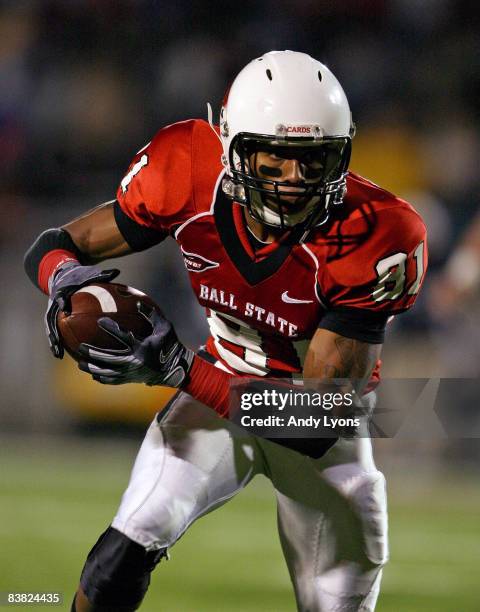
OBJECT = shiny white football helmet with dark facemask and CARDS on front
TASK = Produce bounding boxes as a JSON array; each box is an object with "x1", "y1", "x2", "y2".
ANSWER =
[{"x1": 216, "y1": 51, "x2": 355, "y2": 228}]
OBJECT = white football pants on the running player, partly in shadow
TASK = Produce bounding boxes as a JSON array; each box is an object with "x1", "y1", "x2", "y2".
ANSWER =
[{"x1": 112, "y1": 392, "x2": 388, "y2": 612}]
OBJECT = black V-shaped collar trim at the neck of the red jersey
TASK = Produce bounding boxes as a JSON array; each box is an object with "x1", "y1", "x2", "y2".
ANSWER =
[{"x1": 214, "y1": 189, "x2": 304, "y2": 286}]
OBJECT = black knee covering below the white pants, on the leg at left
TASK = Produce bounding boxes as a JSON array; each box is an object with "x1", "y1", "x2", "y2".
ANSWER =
[{"x1": 80, "y1": 527, "x2": 167, "y2": 610}]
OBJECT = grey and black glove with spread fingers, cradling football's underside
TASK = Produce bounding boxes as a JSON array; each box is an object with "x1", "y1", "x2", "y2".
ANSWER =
[{"x1": 78, "y1": 302, "x2": 195, "y2": 387}]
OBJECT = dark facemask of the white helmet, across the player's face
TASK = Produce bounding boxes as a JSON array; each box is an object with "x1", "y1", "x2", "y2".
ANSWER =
[{"x1": 224, "y1": 132, "x2": 351, "y2": 229}]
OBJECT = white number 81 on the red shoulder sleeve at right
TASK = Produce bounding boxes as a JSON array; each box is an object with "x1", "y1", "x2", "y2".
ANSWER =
[{"x1": 372, "y1": 241, "x2": 424, "y2": 302}]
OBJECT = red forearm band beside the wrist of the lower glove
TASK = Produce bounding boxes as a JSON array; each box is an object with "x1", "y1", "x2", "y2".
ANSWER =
[{"x1": 183, "y1": 355, "x2": 234, "y2": 417}]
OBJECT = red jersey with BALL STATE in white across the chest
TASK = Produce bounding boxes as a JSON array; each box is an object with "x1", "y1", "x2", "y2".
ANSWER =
[{"x1": 117, "y1": 120, "x2": 427, "y2": 376}]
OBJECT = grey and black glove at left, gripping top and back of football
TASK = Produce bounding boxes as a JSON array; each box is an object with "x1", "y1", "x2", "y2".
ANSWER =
[{"x1": 45, "y1": 262, "x2": 120, "y2": 359}]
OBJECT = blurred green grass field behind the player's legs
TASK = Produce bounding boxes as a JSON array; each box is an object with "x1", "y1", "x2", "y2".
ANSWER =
[{"x1": 0, "y1": 438, "x2": 480, "y2": 612}]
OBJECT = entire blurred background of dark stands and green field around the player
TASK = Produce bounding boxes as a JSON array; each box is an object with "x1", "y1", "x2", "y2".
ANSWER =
[{"x1": 0, "y1": 0, "x2": 480, "y2": 612}]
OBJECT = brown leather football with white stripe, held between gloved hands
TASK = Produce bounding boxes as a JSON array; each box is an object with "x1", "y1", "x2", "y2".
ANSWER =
[{"x1": 57, "y1": 283, "x2": 161, "y2": 361}]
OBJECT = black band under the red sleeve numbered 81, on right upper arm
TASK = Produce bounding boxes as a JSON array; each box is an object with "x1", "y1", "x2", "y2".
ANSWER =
[{"x1": 318, "y1": 308, "x2": 390, "y2": 344}]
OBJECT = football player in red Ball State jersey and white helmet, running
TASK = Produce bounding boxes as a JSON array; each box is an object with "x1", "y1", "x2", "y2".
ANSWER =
[{"x1": 26, "y1": 51, "x2": 426, "y2": 612}]
